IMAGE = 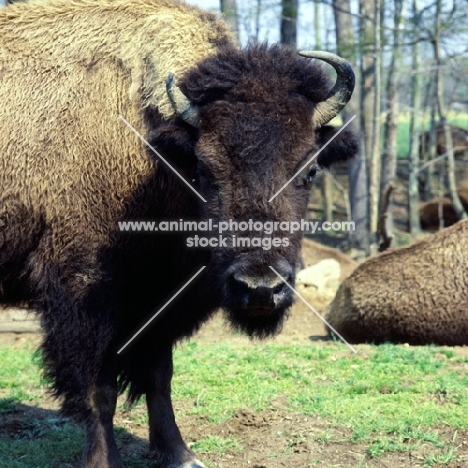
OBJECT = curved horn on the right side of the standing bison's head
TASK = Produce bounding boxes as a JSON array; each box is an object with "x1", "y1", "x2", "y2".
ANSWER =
[{"x1": 299, "y1": 50, "x2": 355, "y2": 128}]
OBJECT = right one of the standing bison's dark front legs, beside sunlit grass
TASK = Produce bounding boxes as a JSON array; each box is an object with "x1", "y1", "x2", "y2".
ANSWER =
[{"x1": 146, "y1": 349, "x2": 205, "y2": 468}]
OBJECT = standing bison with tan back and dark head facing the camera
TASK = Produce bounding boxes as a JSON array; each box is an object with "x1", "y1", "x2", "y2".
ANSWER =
[{"x1": 0, "y1": 0, "x2": 357, "y2": 468}]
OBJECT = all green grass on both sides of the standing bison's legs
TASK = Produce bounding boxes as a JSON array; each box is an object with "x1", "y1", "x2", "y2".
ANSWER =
[{"x1": 0, "y1": 342, "x2": 468, "y2": 468}]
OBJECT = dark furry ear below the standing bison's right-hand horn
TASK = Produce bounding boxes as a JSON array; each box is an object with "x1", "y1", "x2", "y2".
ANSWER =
[{"x1": 316, "y1": 125, "x2": 359, "y2": 168}]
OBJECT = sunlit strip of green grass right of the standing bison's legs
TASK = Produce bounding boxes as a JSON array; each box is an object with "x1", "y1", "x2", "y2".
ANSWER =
[{"x1": 174, "y1": 343, "x2": 468, "y2": 429}]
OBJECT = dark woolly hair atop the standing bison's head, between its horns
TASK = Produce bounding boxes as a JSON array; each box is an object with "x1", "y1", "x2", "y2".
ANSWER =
[{"x1": 180, "y1": 45, "x2": 332, "y2": 105}]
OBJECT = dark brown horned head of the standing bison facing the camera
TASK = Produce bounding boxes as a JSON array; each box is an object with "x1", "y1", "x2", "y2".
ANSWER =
[{"x1": 152, "y1": 46, "x2": 357, "y2": 335}]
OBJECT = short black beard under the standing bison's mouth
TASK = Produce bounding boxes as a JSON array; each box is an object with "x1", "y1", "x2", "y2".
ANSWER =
[{"x1": 224, "y1": 308, "x2": 289, "y2": 339}]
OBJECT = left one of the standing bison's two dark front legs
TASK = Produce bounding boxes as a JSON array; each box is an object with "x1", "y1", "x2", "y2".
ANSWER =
[{"x1": 85, "y1": 352, "x2": 124, "y2": 468}]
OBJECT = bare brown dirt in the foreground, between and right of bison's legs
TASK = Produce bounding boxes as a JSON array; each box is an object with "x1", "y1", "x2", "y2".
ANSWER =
[{"x1": 110, "y1": 400, "x2": 468, "y2": 468}]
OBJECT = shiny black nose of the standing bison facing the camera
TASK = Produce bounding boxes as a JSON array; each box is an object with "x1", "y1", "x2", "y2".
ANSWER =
[{"x1": 231, "y1": 266, "x2": 293, "y2": 309}]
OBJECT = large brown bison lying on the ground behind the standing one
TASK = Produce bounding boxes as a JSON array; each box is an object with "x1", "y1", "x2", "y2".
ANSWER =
[{"x1": 326, "y1": 221, "x2": 468, "y2": 346}]
